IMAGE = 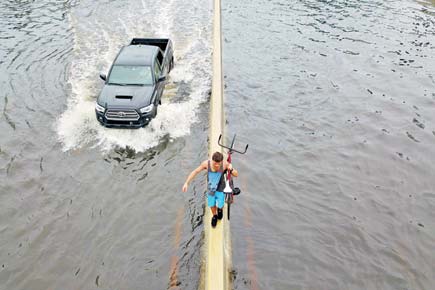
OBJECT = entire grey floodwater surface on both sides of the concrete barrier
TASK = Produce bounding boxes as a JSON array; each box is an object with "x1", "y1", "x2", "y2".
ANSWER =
[{"x1": 0, "y1": 0, "x2": 435, "y2": 290}]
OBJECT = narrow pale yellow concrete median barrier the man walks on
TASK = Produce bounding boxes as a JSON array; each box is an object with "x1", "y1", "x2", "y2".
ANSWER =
[{"x1": 204, "y1": 0, "x2": 231, "y2": 290}]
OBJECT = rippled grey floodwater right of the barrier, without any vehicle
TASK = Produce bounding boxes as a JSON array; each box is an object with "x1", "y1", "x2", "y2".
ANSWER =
[{"x1": 223, "y1": 0, "x2": 435, "y2": 290}]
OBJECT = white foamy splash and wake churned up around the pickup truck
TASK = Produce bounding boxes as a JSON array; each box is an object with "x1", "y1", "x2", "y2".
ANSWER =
[{"x1": 56, "y1": 0, "x2": 211, "y2": 151}]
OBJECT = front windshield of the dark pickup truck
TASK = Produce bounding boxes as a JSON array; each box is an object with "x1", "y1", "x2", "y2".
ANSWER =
[{"x1": 108, "y1": 65, "x2": 153, "y2": 85}]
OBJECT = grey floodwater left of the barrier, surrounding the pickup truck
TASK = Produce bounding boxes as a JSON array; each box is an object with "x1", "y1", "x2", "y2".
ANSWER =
[{"x1": 0, "y1": 0, "x2": 211, "y2": 290}]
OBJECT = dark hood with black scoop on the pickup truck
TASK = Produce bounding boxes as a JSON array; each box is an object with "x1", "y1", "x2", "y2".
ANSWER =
[{"x1": 98, "y1": 85, "x2": 154, "y2": 109}]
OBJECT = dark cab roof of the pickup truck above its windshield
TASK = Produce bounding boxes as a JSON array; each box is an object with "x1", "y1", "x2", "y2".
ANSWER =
[{"x1": 114, "y1": 45, "x2": 159, "y2": 65}]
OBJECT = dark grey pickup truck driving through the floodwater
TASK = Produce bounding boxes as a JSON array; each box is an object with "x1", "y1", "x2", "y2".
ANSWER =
[{"x1": 95, "y1": 38, "x2": 174, "y2": 128}]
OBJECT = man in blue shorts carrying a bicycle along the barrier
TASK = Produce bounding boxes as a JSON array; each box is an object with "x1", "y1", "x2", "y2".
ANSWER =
[{"x1": 183, "y1": 152, "x2": 239, "y2": 227}]
